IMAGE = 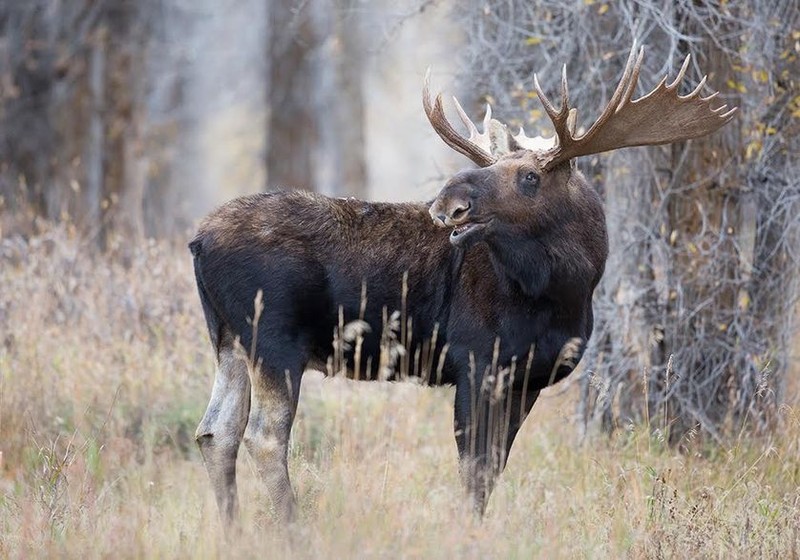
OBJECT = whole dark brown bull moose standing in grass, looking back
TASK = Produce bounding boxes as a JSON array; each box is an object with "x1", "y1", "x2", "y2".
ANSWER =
[{"x1": 189, "y1": 44, "x2": 736, "y2": 525}]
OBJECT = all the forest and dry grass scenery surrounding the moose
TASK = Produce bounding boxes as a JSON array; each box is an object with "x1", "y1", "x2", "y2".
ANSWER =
[{"x1": 0, "y1": 0, "x2": 800, "y2": 559}]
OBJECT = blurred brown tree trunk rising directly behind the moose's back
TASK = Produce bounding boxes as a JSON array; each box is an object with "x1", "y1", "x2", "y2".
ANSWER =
[{"x1": 267, "y1": 0, "x2": 367, "y2": 197}]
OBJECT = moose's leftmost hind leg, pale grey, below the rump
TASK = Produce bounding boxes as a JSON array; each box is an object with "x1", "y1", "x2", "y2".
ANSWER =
[{"x1": 195, "y1": 340, "x2": 250, "y2": 526}]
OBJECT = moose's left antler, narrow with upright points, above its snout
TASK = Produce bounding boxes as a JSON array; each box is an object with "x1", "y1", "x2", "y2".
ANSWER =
[{"x1": 422, "y1": 68, "x2": 508, "y2": 167}]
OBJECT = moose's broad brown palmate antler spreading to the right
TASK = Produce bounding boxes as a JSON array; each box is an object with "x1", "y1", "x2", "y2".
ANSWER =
[{"x1": 513, "y1": 43, "x2": 737, "y2": 169}]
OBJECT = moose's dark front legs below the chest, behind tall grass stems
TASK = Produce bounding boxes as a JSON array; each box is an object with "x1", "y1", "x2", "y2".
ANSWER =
[{"x1": 454, "y1": 379, "x2": 539, "y2": 516}]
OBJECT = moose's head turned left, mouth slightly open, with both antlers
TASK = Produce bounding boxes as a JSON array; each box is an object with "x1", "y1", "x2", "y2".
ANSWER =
[{"x1": 422, "y1": 44, "x2": 737, "y2": 247}]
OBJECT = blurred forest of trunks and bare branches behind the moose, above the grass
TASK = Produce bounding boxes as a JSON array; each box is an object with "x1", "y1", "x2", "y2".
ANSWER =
[{"x1": 0, "y1": 0, "x2": 800, "y2": 443}]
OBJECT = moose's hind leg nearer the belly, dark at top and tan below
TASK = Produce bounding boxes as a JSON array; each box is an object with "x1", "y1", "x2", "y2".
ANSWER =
[{"x1": 244, "y1": 356, "x2": 303, "y2": 522}]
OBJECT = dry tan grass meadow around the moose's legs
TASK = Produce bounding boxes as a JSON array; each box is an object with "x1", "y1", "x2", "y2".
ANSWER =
[{"x1": 0, "y1": 222, "x2": 800, "y2": 559}]
